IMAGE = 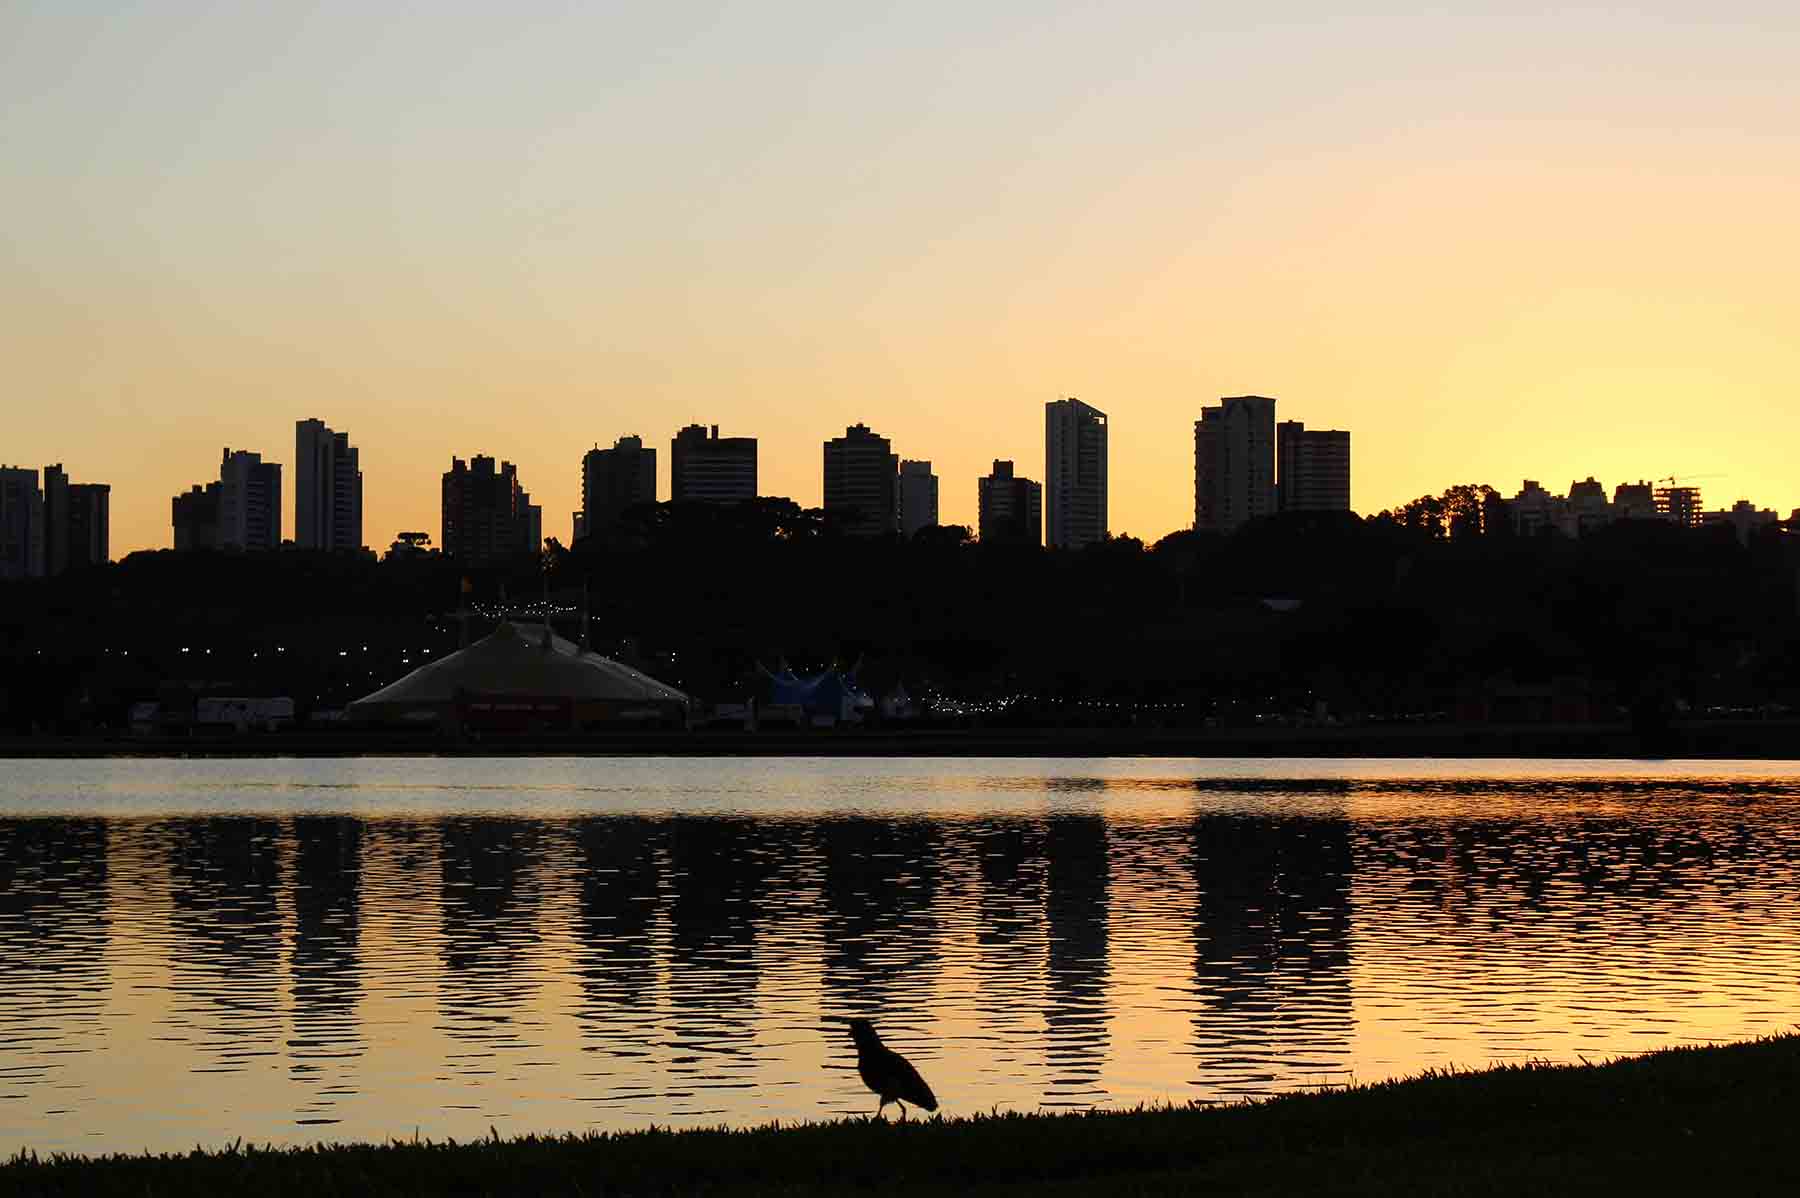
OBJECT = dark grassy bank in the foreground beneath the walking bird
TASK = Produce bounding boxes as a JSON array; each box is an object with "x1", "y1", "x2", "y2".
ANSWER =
[{"x1": 0, "y1": 1036, "x2": 1800, "y2": 1198}]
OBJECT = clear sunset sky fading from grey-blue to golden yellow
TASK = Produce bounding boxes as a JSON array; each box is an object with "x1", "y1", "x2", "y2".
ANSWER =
[{"x1": 0, "y1": 0, "x2": 1800, "y2": 556}]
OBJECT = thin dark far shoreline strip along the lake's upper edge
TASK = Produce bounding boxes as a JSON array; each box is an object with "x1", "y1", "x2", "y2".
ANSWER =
[{"x1": 0, "y1": 720, "x2": 1800, "y2": 761}]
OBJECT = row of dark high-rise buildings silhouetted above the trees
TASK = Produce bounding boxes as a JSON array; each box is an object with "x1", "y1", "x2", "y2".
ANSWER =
[{"x1": 10, "y1": 396, "x2": 1800, "y2": 564}]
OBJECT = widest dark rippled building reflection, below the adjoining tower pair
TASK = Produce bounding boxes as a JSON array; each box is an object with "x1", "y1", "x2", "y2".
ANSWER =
[{"x1": 1192, "y1": 815, "x2": 1354, "y2": 1092}]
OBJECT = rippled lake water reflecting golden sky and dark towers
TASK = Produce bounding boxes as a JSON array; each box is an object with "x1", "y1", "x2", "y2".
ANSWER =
[{"x1": 0, "y1": 757, "x2": 1800, "y2": 1153}]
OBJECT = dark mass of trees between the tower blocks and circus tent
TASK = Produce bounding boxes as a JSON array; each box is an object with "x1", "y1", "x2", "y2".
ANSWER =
[{"x1": 0, "y1": 486, "x2": 1800, "y2": 732}]
